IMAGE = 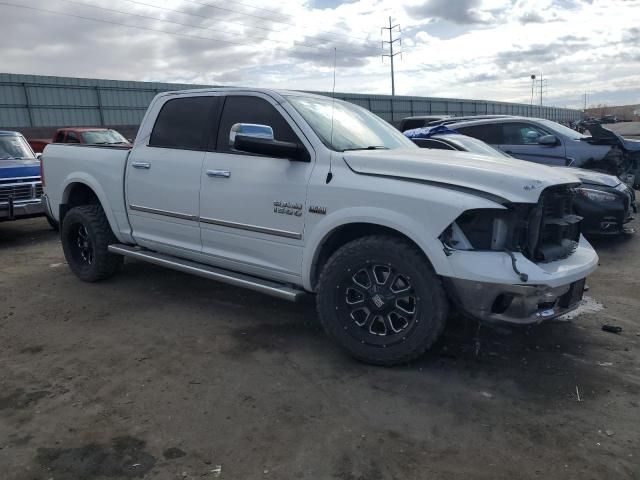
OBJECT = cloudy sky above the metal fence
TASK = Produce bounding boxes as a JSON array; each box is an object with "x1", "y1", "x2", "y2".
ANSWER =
[{"x1": 0, "y1": 0, "x2": 640, "y2": 107}]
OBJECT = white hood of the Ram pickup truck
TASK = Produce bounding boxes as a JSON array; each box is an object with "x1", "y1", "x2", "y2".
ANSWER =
[{"x1": 342, "y1": 148, "x2": 580, "y2": 203}]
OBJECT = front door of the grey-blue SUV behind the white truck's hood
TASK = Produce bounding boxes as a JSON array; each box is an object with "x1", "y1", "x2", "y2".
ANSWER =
[{"x1": 500, "y1": 122, "x2": 566, "y2": 166}]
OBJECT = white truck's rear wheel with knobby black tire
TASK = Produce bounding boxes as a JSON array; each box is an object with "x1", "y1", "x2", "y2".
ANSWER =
[{"x1": 60, "y1": 205, "x2": 124, "y2": 282}]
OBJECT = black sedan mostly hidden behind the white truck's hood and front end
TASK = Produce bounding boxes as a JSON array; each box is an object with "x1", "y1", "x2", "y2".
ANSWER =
[{"x1": 404, "y1": 126, "x2": 637, "y2": 235}]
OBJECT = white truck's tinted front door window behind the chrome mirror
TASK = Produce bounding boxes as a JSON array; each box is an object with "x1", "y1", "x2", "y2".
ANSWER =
[{"x1": 216, "y1": 96, "x2": 300, "y2": 152}]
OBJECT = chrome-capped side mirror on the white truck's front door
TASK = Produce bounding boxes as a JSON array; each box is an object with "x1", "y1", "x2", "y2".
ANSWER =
[{"x1": 229, "y1": 123, "x2": 311, "y2": 162}]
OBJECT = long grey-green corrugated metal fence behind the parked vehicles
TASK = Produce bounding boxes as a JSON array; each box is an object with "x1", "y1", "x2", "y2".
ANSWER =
[{"x1": 0, "y1": 73, "x2": 582, "y2": 128}]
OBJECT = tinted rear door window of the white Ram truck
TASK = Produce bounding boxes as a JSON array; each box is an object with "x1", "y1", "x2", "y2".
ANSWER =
[{"x1": 149, "y1": 97, "x2": 219, "y2": 150}]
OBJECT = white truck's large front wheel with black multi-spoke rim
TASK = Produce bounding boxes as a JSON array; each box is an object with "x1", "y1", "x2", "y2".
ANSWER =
[{"x1": 317, "y1": 235, "x2": 448, "y2": 365}]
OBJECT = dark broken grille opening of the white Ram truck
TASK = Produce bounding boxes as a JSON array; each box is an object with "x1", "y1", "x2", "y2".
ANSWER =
[{"x1": 528, "y1": 185, "x2": 582, "y2": 262}]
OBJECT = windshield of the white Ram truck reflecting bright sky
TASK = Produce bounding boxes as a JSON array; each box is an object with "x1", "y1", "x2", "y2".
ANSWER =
[{"x1": 288, "y1": 95, "x2": 419, "y2": 152}]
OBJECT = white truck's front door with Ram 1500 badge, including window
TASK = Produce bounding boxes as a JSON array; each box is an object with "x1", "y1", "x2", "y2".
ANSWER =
[{"x1": 200, "y1": 94, "x2": 314, "y2": 279}]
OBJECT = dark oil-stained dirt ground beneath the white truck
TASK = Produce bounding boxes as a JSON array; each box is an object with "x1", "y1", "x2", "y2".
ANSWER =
[{"x1": 0, "y1": 219, "x2": 640, "y2": 480}]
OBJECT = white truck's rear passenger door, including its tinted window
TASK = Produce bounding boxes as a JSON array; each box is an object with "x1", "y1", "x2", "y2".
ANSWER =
[{"x1": 126, "y1": 96, "x2": 219, "y2": 256}]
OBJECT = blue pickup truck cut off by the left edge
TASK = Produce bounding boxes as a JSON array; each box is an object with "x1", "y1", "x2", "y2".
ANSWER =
[{"x1": 0, "y1": 131, "x2": 45, "y2": 221}]
